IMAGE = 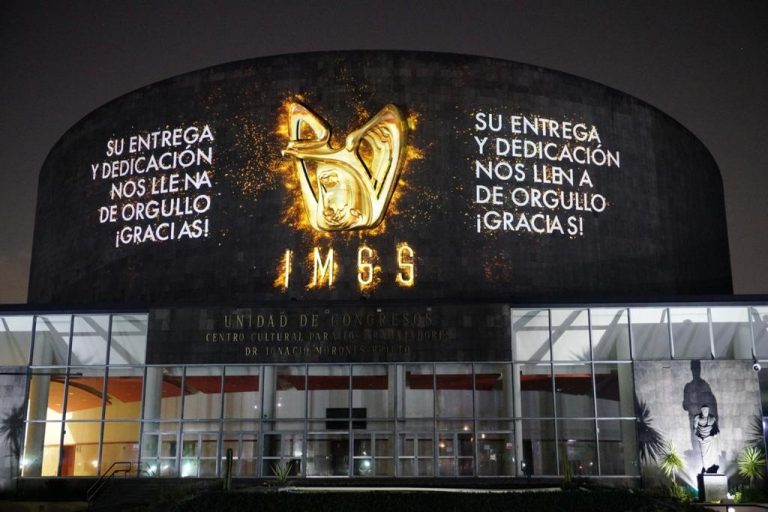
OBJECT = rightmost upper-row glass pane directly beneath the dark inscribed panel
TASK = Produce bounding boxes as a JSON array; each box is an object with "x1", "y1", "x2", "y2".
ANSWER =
[{"x1": 475, "y1": 364, "x2": 515, "y2": 418}]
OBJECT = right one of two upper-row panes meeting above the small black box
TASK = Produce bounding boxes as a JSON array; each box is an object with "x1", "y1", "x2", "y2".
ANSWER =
[{"x1": 352, "y1": 364, "x2": 396, "y2": 418}]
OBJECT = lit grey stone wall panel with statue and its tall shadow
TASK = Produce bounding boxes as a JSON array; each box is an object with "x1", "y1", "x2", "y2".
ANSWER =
[{"x1": 635, "y1": 360, "x2": 762, "y2": 486}]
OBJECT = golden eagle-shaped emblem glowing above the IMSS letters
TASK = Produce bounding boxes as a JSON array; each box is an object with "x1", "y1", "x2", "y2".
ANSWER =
[{"x1": 282, "y1": 103, "x2": 407, "y2": 231}]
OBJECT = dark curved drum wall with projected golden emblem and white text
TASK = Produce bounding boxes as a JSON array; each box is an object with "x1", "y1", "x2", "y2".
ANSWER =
[{"x1": 30, "y1": 52, "x2": 731, "y2": 305}]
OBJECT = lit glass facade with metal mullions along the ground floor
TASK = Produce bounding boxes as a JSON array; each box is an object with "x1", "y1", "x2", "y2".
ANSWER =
[{"x1": 0, "y1": 305, "x2": 768, "y2": 478}]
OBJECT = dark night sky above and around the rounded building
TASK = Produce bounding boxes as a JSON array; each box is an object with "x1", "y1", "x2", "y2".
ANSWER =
[{"x1": 0, "y1": 0, "x2": 768, "y2": 303}]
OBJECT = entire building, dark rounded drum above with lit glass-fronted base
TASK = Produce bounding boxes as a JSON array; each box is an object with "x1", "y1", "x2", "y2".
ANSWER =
[{"x1": 0, "y1": 51, "x2": 768, "y2": 488}]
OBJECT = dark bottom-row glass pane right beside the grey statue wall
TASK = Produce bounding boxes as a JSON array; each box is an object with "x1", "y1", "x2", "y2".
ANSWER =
[{"x1": 597, "y1": 420, "x2": 640, "y2": 476}]
